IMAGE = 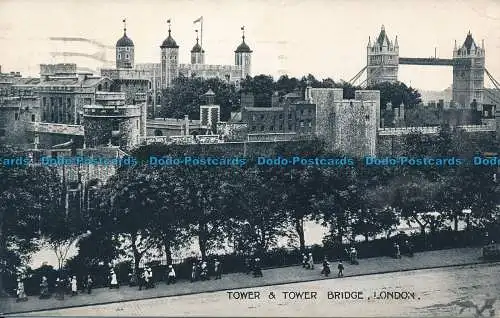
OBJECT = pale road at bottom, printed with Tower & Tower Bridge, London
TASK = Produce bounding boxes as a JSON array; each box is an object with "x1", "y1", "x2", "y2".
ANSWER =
[{"x1": 11, "y1": 264, "x2": 500, "y2": 317}]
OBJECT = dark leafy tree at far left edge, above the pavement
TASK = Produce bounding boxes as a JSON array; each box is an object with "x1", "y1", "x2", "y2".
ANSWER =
[{"x1": 0, "y1": 158, "x2": 62, "y2": 296}]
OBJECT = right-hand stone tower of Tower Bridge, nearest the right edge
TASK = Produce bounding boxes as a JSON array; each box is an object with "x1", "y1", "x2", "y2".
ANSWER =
[{"x1": 452, "y1": 31, "x2": 485, "y2": 110}]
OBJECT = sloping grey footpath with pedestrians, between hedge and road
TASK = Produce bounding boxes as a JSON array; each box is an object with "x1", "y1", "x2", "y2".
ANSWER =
[{"x1": 0, "y1": 248, "x2": 496, "y2": 315}]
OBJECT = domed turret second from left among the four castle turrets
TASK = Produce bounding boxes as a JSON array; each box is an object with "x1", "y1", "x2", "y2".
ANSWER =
[{"x1": 160, "y1": 20, "x2": 179, "y2": 88}]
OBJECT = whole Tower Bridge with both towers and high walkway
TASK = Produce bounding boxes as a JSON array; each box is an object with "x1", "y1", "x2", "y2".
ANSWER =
[{"x1": 349, "y1": 26, "x2": 500, "y2": 110}]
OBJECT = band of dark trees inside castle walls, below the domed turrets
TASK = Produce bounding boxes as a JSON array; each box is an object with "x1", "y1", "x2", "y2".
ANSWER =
[{"x1": 156, "y1": 74, "x2": 421, "y2": 121}]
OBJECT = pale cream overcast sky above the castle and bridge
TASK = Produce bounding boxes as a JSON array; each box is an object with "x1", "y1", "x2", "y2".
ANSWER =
[{"x1": 0, "y1": 0, "x2": 500, "y2": 90}]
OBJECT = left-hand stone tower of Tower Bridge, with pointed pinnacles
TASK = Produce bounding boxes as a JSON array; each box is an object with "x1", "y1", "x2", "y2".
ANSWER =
[{"x1": 366, "y1": 25, "x2": 399, "y2": 86}]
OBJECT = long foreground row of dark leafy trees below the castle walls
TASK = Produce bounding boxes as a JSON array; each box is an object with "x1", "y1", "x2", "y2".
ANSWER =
[{"x1": 0, "y1": 128, "x2": 500, "y2": 294}]
